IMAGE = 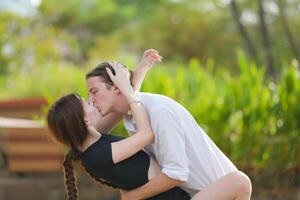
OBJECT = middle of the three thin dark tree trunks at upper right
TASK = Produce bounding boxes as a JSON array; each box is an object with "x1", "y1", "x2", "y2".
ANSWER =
[{"x1": 258, "y1": 0, "x2": 275, "y2": 77}]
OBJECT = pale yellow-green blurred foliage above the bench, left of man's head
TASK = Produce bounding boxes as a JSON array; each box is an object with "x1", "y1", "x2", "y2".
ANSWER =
[{"x1": 0, "y1": 63, "x2": 86, "y2": 101}]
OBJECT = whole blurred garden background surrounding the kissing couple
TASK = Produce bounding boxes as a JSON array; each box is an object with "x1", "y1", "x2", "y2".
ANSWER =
[{"x1": 0, "y1": 0, "x2": 300, "y2": 200}]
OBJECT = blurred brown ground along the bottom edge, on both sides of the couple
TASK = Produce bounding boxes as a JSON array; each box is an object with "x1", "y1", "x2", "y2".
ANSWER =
[{"x1": 0, "y1": 169, "x2": 300, "y2": 200}]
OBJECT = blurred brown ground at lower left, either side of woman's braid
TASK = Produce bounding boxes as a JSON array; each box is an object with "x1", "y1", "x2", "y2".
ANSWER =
[{"x1": 0, "y1": 172, "x2": 119, "y2": 200}]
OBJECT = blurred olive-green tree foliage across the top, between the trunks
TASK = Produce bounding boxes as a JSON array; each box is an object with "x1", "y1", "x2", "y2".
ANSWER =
[{"x1": 0, "y1": 0, "x2": 300, "y2": 74}]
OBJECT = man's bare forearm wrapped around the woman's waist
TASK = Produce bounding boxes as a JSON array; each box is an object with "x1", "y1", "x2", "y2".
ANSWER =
[{"x1": 123, "y1": 172, "x2": 183, "y2": 200}]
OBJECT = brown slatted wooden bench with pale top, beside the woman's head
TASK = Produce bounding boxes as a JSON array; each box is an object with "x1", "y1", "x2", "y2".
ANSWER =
[{"x1": 0, "y1": 117, "x2": 63, "y2": 172}]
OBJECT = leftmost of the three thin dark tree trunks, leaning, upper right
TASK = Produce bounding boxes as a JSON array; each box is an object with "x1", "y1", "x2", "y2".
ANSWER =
[{"x1": 230, "y1": 0, "x2": 257, "y2": 62}]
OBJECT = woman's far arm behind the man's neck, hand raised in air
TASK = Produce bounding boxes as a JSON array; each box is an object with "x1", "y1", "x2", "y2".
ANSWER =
[{"x1": 97, "y1": 49, "x2": 162, "y2": 133}]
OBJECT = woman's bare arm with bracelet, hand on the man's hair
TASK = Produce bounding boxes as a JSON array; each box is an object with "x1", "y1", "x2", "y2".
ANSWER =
[{"x1": 107, "y1": 63, "x2": 154, "y2": 163}]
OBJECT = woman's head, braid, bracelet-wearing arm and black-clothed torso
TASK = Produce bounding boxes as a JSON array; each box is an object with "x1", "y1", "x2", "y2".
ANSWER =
[{"x1": 47, "y1": 61, "x2": 190, "y2": 200}]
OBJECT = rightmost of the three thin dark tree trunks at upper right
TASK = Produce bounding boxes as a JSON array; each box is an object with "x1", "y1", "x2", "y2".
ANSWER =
[{"x1": 278, "y1": 0, "x2": 300, "y2": 62}]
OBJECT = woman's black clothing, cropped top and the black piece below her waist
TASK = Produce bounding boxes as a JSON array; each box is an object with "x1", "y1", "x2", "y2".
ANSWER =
[{"x1": 82, "y1": 134, "x2": 190, "y2": 200}]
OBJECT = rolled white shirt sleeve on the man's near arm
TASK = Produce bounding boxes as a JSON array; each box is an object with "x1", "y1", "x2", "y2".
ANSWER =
[{"x1": 152, "y1": 108, "x2": 189, "y2": 181}]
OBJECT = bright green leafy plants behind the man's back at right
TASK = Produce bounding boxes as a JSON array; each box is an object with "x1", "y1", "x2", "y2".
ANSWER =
[{"x1": 142, "y1": 56, "x2": 300, "y2": 177}]
